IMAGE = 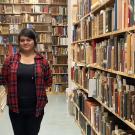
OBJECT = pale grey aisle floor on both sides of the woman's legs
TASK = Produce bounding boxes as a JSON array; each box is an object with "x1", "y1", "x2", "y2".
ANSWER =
[{"x1": 0, "y1": 94, "x2": 81, "y2": 135}]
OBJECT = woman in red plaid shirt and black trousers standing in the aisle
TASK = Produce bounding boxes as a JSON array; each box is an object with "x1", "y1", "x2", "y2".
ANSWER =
[{"x1": 0, "y1": 28, "x2": 52, "y2": 135}]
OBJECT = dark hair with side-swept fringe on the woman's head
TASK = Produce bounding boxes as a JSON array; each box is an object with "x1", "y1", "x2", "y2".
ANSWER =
[{"x1": 18, "y1": 28, "x2": 37, "y2": 46}]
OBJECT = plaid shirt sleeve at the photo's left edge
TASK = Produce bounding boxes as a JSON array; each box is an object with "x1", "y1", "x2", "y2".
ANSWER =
[{"x1": 0, "y1": 57, "x2": 10, "y2": 85}]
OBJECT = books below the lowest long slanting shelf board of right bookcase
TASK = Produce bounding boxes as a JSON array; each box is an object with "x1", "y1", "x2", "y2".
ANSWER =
[{"x1": 74, "y1": 89, "x2": 134, "y2": 135}]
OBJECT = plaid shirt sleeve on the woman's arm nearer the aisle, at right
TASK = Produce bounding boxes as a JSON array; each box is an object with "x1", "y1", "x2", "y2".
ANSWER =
[{"x1": 43, "y1": 59, "x2": 52, "y2": 87}]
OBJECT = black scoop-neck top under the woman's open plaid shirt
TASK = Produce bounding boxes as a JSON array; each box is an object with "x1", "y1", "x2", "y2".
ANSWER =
[{"x1": 17, "y1": 63, "x2": 36, "y2": 112}]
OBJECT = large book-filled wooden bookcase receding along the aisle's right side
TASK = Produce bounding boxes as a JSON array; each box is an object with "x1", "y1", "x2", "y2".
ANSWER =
[{"x1": 69, "y1": 0, "x2": 135, "y2": 135}]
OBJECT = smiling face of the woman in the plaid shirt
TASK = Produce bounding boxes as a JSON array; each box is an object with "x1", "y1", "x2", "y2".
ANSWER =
[{"x1": 19, "y1": 36, "x2": 35, "y2": 52}]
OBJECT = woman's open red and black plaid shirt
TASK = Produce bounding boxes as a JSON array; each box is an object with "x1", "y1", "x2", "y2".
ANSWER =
[{"x1": 0, "y1": 53, "x2": 52, "y2": 116}]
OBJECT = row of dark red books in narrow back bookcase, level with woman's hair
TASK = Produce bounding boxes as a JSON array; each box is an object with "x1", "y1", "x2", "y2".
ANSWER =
[{"x1": 52, "y1": 26, "x2": 67, "y2": 36}]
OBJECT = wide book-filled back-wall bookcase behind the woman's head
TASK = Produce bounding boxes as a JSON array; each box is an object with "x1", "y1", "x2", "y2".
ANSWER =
[{"x1": 0, "y1": 0, "x2": 52, "y2": 59}]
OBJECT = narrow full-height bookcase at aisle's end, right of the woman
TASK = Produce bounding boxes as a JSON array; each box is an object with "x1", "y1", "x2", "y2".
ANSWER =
[{"x1": 51, "y1": 0, "x2": 68, "y2": 92}]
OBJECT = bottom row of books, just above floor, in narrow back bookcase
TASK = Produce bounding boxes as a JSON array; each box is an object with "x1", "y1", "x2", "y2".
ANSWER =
[{"x1": 52, "y1": 84, "x2": 67, "y2": 92}]
